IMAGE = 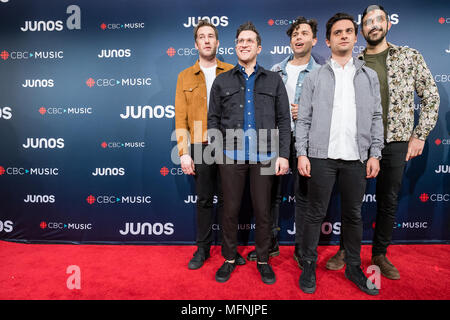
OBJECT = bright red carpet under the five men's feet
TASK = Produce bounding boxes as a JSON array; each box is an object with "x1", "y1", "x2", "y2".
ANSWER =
[{"x1": 0, "y1": 241, "x2": 450, "y2": 300}]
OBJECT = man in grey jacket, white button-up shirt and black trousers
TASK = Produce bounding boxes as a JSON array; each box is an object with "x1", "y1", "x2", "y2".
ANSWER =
[{"x1": 296, "y1": 13, "x2": 383, "y2": 295}]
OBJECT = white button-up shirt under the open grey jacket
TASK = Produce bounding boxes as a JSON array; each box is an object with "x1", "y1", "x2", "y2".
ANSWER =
[{"x1": 328, "y1": 58, "x2": 360, "y2": 160}]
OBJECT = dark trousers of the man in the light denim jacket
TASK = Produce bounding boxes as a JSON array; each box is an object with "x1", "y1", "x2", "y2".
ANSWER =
[{"x1": 271, "y1": 134, "x2": 308, "y2": 256}]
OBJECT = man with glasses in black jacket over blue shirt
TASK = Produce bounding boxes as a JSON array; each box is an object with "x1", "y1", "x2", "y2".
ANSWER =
[{"x1": 208, "y1": 22, "x2": 291, "y2": 284}]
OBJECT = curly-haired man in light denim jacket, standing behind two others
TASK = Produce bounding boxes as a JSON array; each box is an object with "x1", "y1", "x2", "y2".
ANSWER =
[{"x1": 247, "y1": 17, "x2": 320, "y2": 268}]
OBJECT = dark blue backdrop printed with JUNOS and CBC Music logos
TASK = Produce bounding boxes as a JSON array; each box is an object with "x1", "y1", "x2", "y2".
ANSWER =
[{"x1": 0, "y1": 0, "x2": 450, "y2": 244}]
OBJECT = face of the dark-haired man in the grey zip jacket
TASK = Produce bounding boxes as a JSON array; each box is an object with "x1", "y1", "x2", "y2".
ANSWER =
[{"x1": 326, "y1": 19, "x2": 358, "y2": 55}]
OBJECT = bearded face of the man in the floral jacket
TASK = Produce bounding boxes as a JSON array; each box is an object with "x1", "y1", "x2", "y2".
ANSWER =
[{"x1": 361, "y1": 9, "x2": 391, "y2": 46}]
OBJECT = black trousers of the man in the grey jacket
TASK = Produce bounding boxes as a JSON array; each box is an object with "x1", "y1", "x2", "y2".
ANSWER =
[{"x1": 302, "y1": 158, "x2": 366, "y2": 266}]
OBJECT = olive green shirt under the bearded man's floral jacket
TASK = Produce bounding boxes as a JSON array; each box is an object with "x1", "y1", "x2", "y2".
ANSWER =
[{"x1": 364, "y1": 49, "x2": 389, "y2": 139}]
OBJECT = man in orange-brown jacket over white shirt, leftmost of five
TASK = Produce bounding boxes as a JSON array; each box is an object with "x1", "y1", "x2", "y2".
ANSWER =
[{"x1": 175, "y1": 20, "x2": 245, "y2": 270}]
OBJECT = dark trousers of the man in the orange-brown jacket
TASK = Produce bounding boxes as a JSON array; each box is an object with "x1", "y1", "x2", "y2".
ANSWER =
[{"x1": 191, "y1": 144, "x2": 223, "y2": 251}]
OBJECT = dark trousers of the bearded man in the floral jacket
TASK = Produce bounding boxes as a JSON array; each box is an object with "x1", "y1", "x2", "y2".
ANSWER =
[{"x1": 340, "y1": 142, "x2": 408, "y2": 256}]
